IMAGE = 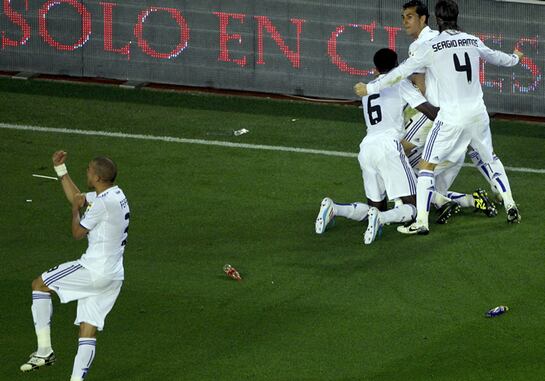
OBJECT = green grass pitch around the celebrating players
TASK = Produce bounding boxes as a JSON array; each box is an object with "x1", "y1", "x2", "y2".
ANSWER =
[{"x1": 0, "y1": 79, "x2": 545, "y2": 381}]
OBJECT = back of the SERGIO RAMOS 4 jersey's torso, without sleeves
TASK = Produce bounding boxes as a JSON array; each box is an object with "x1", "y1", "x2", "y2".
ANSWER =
[{"x1": 426, "y1": 30, "x2": 486, "y2": 123}]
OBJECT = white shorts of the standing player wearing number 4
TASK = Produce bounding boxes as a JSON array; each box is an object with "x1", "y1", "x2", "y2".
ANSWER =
[{"x1": 422, "y1": 112, "x2": 494, "y2": 164}]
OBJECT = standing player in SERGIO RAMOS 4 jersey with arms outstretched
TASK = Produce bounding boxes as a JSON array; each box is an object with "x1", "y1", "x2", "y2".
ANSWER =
[{"x1": 354, "y1": 0, "x2": 522, "y2": 234}]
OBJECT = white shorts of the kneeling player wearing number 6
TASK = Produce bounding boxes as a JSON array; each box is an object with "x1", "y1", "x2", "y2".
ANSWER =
[{"x1": 358, "y1": 135, "x2": 416, "y2": 202}]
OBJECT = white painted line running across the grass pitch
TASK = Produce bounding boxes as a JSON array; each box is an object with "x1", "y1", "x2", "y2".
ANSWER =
[{"x1": 0, "y1": 123, "x2": 545, "y2": 174}]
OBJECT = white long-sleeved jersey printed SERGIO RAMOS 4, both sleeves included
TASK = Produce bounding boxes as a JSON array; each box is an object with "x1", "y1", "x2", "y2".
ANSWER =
[{"x1": 367, "y1": 30, "x2": 519, "y2": 125}]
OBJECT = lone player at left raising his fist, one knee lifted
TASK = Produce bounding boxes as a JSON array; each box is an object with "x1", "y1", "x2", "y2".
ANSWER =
[{"x1": 21, "y1": 151, "x2": 130, "y2": 381}]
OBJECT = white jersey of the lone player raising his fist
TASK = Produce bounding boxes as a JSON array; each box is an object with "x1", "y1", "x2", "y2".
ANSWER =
[{"x1": 79, "y1": 186, "x2": 130, "y2": 280}]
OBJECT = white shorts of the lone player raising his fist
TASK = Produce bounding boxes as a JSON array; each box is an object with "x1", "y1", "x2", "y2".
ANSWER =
[{"x1": 42, "y1": 261, "x2": 123, "y2": 331}]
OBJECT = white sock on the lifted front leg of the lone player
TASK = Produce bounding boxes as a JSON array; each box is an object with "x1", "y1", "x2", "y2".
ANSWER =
[{"x1": 31, "y1": 291, "x2": 53, "y2": 357}]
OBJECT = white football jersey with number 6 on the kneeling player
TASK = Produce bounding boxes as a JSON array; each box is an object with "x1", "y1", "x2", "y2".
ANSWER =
[{"x1": 362, "y1": 75, "x2": 426, "y2": 139}]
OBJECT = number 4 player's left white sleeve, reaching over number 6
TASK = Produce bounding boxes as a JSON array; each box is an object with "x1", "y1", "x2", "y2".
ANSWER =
[{"x1": 367, "y1": 43, "x2": 432, "y2": 94}]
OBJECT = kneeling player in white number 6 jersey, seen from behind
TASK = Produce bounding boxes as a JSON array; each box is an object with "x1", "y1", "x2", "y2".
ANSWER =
[{"x1": 315, "y1": 49, "x2": 437, "y2": 244}]
